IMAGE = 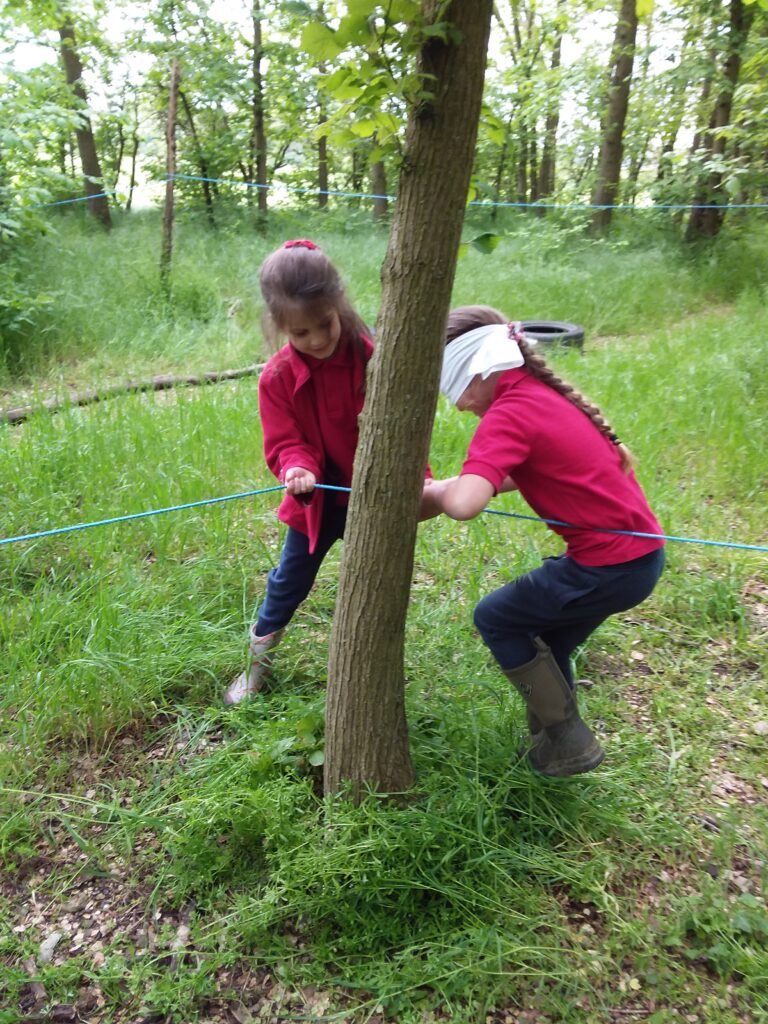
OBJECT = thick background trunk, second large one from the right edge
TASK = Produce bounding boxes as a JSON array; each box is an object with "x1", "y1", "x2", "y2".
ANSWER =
[{"x1": 592, "y1": 0, "x2": 638, "y2": 234}]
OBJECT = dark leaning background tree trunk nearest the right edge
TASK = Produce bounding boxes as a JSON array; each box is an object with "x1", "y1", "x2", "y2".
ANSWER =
[{"x1": 685, "y1": 0, "x2": 755, "y2": 242}]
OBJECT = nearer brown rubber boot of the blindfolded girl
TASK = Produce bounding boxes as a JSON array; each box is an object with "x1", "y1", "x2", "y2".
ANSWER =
[{"x1": 505, "y1": 637, "x2": 605, "y2": 777}]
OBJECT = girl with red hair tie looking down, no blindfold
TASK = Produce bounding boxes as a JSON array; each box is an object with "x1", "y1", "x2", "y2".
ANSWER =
[{"x1": 224, "y1": 240, "x2": 373, "y2": 703}]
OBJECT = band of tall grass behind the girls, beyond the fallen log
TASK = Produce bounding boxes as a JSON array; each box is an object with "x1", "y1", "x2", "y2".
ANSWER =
[{"x1": 5, "y1": 204, "x2": 768, "y2": 389}]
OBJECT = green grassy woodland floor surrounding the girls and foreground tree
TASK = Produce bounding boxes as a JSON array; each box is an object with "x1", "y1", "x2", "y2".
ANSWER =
[{"x1": 0, "y1": 209, "x2": 768, "y2": 1024}]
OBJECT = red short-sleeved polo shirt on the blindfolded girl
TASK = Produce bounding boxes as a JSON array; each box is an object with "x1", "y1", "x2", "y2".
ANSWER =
[{"x1": 462, "y1": 367, "x2": 664, "y2": 565}]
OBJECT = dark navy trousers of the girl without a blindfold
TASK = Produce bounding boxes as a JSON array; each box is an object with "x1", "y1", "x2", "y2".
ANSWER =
[{"x1": 256, "y1": 496, "x2": 347, "y2": 637}]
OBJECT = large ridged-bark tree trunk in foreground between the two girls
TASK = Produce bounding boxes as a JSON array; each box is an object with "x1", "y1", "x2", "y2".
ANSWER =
[{"x1": 325, "y1": 0, "x2": 492, "y2": 799}]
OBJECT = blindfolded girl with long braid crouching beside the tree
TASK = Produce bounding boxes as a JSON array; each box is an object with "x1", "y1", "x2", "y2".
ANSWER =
[{"x1": 422, "y1": 306, "x2": 664, "y2": 775}]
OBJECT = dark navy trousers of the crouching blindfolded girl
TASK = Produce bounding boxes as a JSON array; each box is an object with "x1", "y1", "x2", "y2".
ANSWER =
[{"x1": 474, "y1": 548, "x2": 664, "y2": 684}]
